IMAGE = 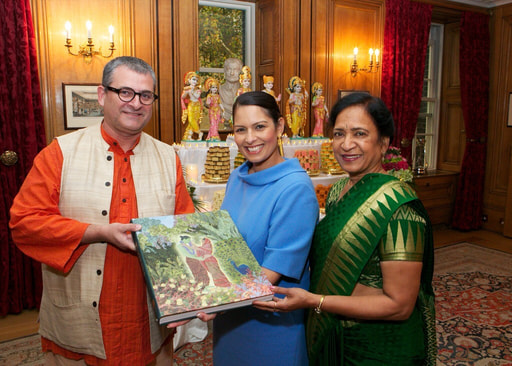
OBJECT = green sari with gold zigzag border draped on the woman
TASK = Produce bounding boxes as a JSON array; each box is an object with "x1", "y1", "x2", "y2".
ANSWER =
[{"x1": 306, "y1": 174, "x2": 437, "y2": 366}]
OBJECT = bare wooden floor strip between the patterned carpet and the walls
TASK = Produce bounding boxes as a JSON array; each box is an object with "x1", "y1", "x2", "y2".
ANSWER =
[{"x1": 0, "y1": 227, "x2": 512, "y2": 342}]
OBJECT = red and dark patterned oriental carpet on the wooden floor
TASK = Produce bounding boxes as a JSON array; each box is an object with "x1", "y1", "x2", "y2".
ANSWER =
[{"x1": 0, "y1": 243, "x2": 512, "y2": 366}]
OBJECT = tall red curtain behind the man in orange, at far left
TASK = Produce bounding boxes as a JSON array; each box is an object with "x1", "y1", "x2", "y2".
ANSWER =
[{"x1": 0, "y1": 0, "x2": 46, "y2": 316}]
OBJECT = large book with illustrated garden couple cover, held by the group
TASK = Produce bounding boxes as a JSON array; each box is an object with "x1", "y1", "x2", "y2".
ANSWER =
[{"x1": 132, "y1": 210, "x2": 272, "y2": 324}]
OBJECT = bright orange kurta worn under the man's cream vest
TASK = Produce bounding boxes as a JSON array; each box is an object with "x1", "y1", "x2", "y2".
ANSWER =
[{"x1": 11, "y1": 129, "x2": 194, "y2": 365}]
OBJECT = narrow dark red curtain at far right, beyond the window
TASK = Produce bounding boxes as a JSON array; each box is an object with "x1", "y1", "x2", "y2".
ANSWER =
[{"x1": 452, "y1": 12, "x2": 490, "y2": 230}]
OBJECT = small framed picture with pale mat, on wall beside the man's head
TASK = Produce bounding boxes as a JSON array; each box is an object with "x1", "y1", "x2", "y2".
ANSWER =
[{"x1": 62, "y1": 83, "x2": 103, "y2": 130}]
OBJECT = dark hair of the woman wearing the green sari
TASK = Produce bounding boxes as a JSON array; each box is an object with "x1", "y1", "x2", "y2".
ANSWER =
[{"x1": 329, "y1": 92, "x2": 395, "y2": 144}]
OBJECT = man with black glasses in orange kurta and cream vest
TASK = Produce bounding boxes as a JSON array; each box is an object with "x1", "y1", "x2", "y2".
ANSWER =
[{"x1": 10, "y1": 57, "x2": 194, "y2": 365}]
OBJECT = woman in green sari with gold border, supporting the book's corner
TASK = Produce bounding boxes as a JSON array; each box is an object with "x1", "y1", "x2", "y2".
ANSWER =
[{"x1": 254, "y1": 93, "x2": 437, "y2": 366}]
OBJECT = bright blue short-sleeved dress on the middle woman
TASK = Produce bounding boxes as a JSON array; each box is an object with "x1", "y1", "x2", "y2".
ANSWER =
[{"x1": 213, "y1": 159, "x2": 318, "y2": 366}]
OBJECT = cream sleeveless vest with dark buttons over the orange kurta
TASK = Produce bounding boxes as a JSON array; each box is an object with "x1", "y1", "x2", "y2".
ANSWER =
[{"x1": 39, "y1": 125, "x2": 176, "y2": 359}]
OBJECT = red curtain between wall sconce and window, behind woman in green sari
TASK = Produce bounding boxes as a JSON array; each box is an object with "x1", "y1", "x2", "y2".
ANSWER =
[{"x1": 381, "y1": 0, "x2": 432, "y2": 162}]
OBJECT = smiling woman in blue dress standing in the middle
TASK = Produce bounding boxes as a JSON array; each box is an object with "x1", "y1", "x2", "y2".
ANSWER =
[{"x1": 199, "y1": 91, "x2": 318, "y2": 366}]
